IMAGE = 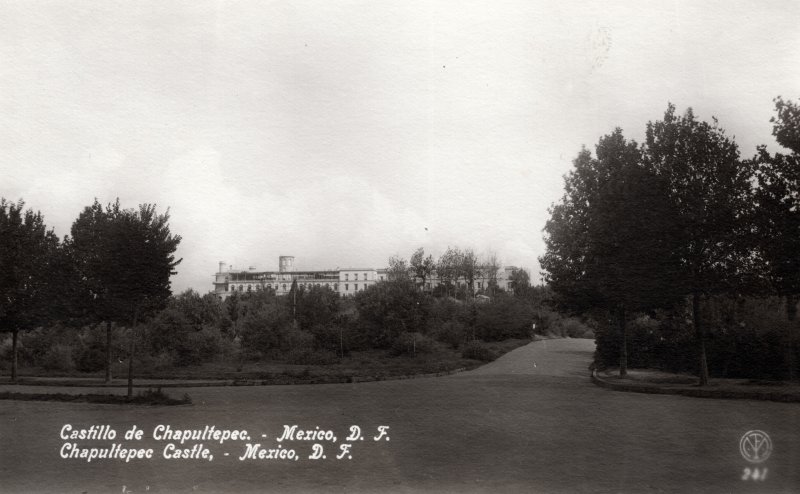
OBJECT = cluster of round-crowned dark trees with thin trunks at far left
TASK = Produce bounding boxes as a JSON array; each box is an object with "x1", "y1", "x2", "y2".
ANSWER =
[{"x1": 0, "y1": 199, "x2": 181, "y2": 396}]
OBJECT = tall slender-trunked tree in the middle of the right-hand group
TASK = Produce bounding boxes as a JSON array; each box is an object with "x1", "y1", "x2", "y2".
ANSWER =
[{"x1": 644, "y1": 104, "x2": 753, "y2": 386}]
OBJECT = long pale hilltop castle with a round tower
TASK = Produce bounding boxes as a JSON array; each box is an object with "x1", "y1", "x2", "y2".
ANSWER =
[{"x1": 214, "y1": 256, "x2": 516, "y2": 299}]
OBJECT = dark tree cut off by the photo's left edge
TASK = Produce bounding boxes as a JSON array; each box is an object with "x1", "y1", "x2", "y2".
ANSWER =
[{"x1": 0, "y1": 198, "x2": 61, "y2": 381}]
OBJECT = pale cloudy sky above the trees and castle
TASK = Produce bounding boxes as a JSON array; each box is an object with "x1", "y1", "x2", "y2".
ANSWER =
[{"x1": 0, "y1": 0, "x2": 800, "y2": 293}]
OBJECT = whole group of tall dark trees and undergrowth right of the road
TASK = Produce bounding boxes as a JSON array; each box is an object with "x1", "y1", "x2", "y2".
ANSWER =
[{"x1": 540, "y1": 97, "x2": 800, "y2": 385}]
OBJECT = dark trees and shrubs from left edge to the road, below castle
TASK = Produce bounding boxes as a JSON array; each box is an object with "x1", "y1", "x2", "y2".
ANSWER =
[{"x1": 0, "y1": 212, "x2": 591, "y2": 378}]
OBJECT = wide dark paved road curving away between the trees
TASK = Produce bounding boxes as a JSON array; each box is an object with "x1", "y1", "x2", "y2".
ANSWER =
[{"x1": 0, "y1": 340, "x2": 800, "y2": 493}]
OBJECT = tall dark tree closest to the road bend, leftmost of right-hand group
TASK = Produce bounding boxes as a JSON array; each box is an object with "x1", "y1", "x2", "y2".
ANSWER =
[{"x1": 544, "y1": 128, "x2": 681, "y2": 375}]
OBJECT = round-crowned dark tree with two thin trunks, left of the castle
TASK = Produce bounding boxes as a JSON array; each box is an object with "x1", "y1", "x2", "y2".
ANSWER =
[{"x1": 70, "y1": 200, "x2": 181, "y2": 396}]
